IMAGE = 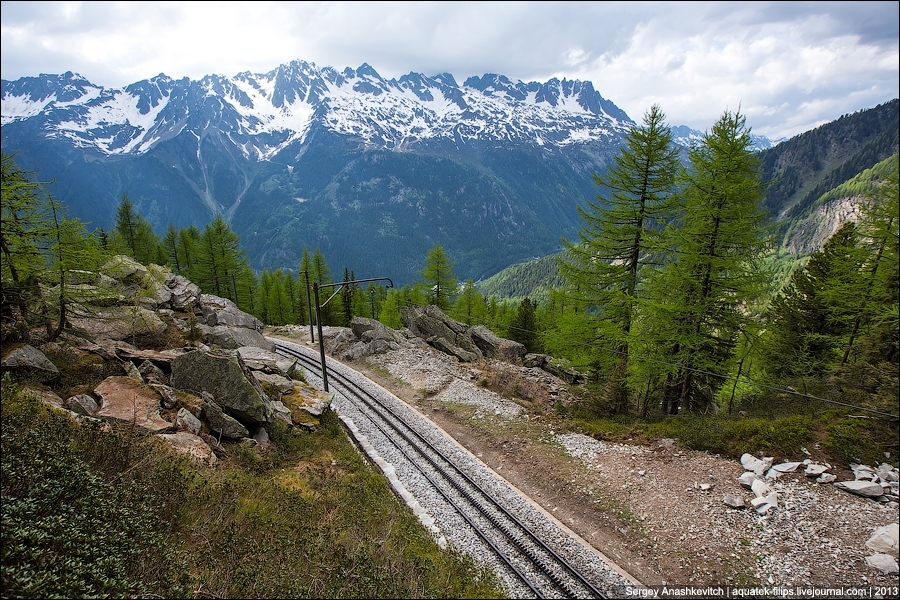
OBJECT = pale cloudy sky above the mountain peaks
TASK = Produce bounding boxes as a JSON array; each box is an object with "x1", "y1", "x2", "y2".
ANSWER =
[{"x1": 0, "y1": 1, "x2": 900, "y2": 139}]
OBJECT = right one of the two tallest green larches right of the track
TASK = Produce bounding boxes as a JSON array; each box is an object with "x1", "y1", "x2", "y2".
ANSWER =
[{"x1": 644, "y1": 111, "x2": 769, "y2": 414}]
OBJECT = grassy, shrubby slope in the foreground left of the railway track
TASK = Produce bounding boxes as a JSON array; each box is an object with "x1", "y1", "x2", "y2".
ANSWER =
[{"x1": 2, "y1": 380, "x2": 502, "y2": 598}]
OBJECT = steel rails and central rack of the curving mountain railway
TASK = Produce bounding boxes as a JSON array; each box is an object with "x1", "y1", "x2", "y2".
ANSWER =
[{"x1": 275, "y1": 341, "x2": 607, "y2": 598}]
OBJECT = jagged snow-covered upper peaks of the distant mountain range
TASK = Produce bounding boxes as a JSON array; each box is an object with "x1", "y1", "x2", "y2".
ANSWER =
[{"x1": 2, "y1": 61, "x2": 632, "y2": 161}]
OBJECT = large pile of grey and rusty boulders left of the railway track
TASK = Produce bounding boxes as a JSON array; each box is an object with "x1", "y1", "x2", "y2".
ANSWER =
[{"x1": 0, "y1": 256, "x2": 332, "y2": 464}]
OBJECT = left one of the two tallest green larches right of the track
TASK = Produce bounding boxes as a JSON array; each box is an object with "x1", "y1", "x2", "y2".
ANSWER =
[{"x1": 559, "y1": 104, "x2": 680, "y2": 411}]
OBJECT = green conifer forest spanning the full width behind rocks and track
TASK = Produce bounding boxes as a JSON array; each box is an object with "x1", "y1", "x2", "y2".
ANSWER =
[{"x1": 2, "y1": 98, "x2": 898, "y2": 438}]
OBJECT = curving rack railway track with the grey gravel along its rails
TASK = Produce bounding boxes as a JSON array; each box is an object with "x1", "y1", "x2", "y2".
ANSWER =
[{"x1": 273, "y1": 340, "x2": 608, "y2": 598}]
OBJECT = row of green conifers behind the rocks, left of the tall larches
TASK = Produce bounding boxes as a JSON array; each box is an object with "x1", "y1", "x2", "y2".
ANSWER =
[{"x1": 0, "y1": 154, "x2": 533, "y2": 346}]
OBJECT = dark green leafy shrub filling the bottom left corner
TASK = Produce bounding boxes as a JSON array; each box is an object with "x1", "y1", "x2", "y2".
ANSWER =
[{"x1": 2, "y1": 383, "x2": 187, "y2": 598}]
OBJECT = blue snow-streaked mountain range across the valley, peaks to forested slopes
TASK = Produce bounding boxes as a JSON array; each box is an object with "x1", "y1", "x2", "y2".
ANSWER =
[{"x1": 2, "y1": 61, "x2": 828, "y2": 284}]
